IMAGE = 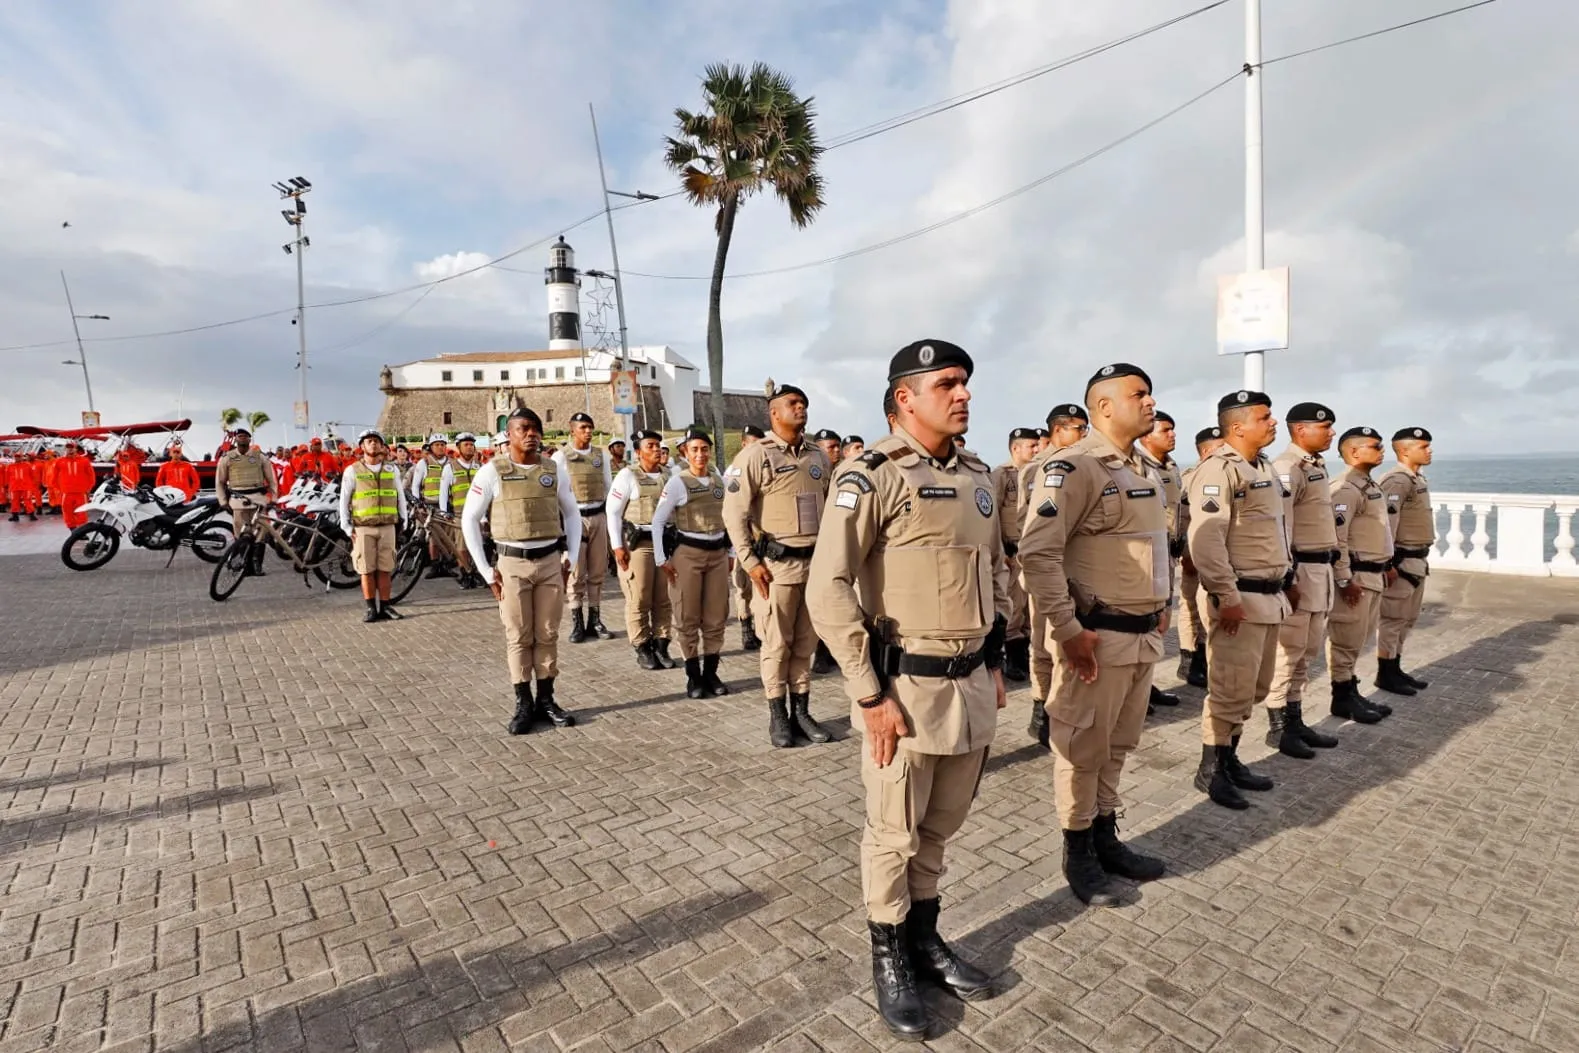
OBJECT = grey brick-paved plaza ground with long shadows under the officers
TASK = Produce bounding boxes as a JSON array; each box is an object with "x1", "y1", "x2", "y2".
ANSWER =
[{"x1": 0, "y1": 519, "x2": 1579, "y2": 1053}]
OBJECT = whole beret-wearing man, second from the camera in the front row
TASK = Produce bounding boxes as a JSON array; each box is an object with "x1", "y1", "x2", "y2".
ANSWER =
[{"x1": 1020, "y1": 362, "x2": 1173, "y2": 906}]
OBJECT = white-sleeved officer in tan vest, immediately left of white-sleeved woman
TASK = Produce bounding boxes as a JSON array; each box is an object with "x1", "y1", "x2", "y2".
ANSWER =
[{"x1": 603, "y1": 431, "x2": 674, "y2": 669}]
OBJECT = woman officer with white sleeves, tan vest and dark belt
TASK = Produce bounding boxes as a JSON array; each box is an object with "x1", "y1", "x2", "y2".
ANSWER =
[{"x1": 652, "y1": 425, "x2": 729, "y2": 698}]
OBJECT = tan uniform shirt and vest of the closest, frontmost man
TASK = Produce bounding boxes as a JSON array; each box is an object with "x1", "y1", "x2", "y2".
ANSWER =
[{"x1": 805, "y1": 428, "x2": 1009, "y2": 755}]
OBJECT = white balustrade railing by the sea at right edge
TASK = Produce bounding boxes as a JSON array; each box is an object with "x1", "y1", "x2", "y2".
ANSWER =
[{"x1": 1432, "y1": 494, "x2": 1579, "y2": 578}]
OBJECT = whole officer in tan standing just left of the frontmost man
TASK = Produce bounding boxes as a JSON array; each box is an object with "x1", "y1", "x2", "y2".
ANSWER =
[{"x1": 723, "y1": 380, "x2": 832, "y2": 748}]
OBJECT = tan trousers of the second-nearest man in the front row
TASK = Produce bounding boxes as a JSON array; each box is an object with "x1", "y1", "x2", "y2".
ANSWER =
[{"x1": 1047, "y1": 647, "x2": 1154, "y2": 830}]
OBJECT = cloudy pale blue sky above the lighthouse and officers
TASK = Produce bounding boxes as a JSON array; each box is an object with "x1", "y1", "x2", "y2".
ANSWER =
[{"x1": 0, "y1": 0, "x2": 1579, "y2": 453}]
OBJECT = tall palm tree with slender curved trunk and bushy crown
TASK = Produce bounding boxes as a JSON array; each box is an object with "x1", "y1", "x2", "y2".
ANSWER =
[{"x1": 663, "y1": 62, "x2": 823, "y2": 450}]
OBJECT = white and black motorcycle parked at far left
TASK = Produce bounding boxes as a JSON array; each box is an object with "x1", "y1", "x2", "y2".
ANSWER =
[{"x1": 60, "y1": 475, "x2": 231, "y2": 570}]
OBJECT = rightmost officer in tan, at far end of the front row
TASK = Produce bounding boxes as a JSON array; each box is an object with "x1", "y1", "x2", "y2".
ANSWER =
[{"x1": 1377, "y1": 428, "x2": 1437, "y2": 695}]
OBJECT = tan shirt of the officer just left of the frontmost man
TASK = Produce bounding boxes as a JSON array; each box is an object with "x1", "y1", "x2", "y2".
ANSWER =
[{"x1": 723, "y1": 433, "x2": 832, "y2": 586}]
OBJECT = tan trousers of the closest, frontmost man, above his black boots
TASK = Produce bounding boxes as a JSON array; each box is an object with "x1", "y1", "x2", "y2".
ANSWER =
[{"x1": 861, "y1": 744, "x2": 987, "y2": 925}]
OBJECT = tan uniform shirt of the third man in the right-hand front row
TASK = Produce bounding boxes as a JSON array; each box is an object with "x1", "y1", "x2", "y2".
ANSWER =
[{"x1": 1189, "y1": 445, "x2": 1290, "y2": 625}]
